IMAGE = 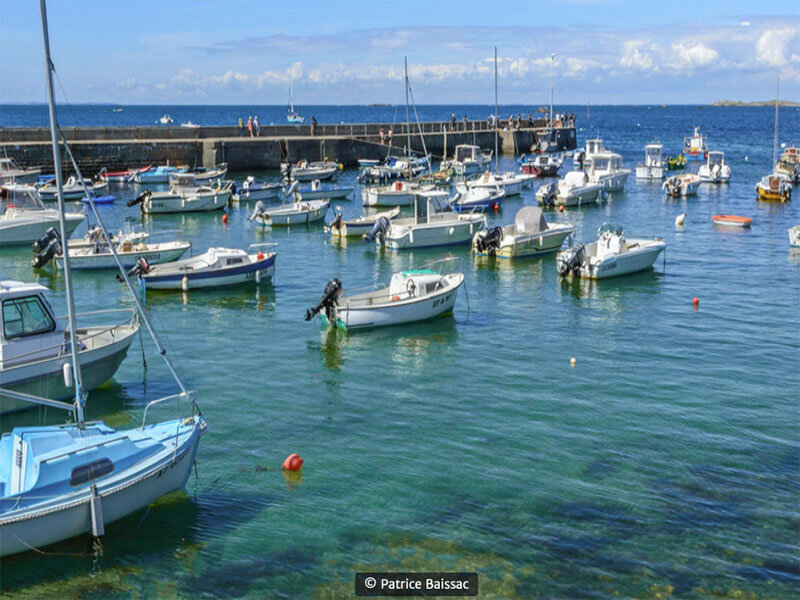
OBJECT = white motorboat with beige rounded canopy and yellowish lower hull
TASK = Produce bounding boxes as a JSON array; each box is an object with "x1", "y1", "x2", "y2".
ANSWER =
[{"x1": 472, "y1": 206, "x2": 575, "y2": 258}]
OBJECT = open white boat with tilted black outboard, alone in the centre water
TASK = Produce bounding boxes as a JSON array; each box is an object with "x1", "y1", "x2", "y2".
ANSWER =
[{"x1": 306, "y1": 258, "x2": 464, "y2": 331}]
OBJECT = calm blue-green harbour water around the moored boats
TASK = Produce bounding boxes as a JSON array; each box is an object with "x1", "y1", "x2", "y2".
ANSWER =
[{"x1": 0, "y1": 106, "x2": 800, "y2": 598}]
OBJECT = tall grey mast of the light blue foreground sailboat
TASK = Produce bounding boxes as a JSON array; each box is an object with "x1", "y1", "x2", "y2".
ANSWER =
[{"x1": 39, "y1": 0, "x2": 84, "y2": 427}]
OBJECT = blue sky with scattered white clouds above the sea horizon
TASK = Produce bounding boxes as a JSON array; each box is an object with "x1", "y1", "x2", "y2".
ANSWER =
[{"x1": 0, "y1": 0, "x2": 800, "y2": 105}]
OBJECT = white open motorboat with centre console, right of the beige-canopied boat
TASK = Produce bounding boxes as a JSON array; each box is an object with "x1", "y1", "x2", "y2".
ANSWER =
[{"x1": 556, "y1": 223, "x2": 667, "y2": 279}]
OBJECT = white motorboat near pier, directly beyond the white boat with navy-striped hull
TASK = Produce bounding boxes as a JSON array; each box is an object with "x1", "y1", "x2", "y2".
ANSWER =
[{"x1": 128, "y1": 173, "x2": 233, "y2": 214}]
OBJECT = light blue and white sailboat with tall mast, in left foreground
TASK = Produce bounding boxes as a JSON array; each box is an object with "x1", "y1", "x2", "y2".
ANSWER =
[{"x1": 0, "y1": 0, "x2": 206, "y2": 556}]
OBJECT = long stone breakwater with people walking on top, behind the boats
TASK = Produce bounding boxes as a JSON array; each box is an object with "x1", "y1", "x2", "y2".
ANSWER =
[{"x1": 0, "y1": 119, "x2": 577, "y2": 175}]
